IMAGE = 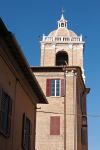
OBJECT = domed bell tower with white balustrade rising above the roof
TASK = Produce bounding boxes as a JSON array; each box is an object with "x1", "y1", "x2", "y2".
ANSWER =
[{"x1": 40, "y1": 11, "x2": 85, "y2": 80}]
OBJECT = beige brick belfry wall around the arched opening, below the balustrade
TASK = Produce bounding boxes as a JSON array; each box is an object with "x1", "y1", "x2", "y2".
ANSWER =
[{"x1": 41, "y1": 42, "x2": 83, "y2": 69}]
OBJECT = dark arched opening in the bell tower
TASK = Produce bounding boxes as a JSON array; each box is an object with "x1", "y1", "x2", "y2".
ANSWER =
[{"x1": 56, "y1": 52, "x2": 68, "y2": 66}]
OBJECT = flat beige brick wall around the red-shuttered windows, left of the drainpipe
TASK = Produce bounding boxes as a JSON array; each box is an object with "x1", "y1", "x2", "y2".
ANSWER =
[{"x1": 35, "y1": 72, "x2": 64, "y2": 150}]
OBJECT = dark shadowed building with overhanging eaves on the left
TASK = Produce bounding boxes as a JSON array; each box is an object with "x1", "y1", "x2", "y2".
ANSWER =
[{"x1": 0, "y1": 19, "x2": 47, "y2": 150}]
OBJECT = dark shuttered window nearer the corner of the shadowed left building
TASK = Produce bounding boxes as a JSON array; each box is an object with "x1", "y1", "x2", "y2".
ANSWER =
[{"x1": 22, "y1": 114, "x2": 31, "y2": 150}]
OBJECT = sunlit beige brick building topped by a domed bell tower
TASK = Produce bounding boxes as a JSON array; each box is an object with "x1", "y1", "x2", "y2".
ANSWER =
[{"x1": 31, "y1": 13, "x2": 89, "y2": 150}]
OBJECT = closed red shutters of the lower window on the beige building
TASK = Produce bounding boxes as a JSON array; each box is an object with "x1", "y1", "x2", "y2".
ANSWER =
[{"x1": 50, "y1": 116, "x2": 60, "y2": 135}]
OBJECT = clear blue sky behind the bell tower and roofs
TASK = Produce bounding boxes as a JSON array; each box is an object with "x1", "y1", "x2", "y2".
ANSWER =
[{"x1": 0, "y1": 0, "x2": 100, "y2": 150}]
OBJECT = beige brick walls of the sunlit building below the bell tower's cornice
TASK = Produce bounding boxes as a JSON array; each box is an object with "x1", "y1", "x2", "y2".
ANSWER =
[{"x1": 35, "y1": 71, "x2": 87, "y2": 150}]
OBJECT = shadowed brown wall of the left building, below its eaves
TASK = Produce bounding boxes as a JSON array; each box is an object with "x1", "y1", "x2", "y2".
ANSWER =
[{"x1": 0, "y1": 56, "x2": 36, "y2": 150}]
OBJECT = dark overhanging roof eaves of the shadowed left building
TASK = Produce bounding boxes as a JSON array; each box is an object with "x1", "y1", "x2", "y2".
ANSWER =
[{"x1": 0, "y1": 18, "x2": 47, "y2": 103}]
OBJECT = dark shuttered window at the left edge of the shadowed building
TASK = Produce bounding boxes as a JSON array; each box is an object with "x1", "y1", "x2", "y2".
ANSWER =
[{"x1": 0, "y1": 89, "x2": 12, "y2": 136}]
